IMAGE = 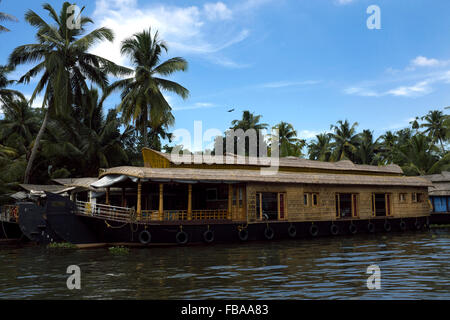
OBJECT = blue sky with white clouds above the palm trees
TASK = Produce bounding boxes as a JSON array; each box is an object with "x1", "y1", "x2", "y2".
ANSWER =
[{"x1": 0, "y1": 0, "x2": 450, "y2": 149}]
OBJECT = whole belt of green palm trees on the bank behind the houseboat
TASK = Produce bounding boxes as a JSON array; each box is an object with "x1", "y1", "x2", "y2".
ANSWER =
[{"x1": 0, "y1": 2, "x2": 450, "y2": 203}]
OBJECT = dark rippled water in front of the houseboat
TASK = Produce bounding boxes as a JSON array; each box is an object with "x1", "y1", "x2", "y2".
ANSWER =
[{"x1": 0, "y1": 228, "x2": 450, "y2": 300}]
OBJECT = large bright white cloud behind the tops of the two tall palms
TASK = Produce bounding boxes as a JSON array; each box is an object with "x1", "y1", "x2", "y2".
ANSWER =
[{"x1": 93, "y1": 0, "x2": 250, "y2": 67}]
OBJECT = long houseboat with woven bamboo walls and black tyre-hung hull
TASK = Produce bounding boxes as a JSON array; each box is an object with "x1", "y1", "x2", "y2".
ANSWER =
[{"x1": 24, "y1": 149, "x2": 431, "y2": 246}]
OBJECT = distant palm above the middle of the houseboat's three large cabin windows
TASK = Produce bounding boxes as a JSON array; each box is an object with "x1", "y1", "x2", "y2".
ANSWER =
[{"x1": 330, "y1": 120, "x2": 359, "y2": 161}]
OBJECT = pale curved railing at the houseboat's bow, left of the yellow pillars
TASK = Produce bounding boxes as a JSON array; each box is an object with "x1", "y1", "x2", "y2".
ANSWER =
[{"x1": 76, "y1": 201, "x2": 134, "y2": 221}]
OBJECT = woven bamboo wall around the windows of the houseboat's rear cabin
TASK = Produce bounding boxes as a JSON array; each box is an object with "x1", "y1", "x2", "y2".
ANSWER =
[{"x1": 247, "y1": 183, "x2": 430, "y2": 221}]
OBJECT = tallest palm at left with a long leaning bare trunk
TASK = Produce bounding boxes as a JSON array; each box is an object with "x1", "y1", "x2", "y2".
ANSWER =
[{"x1": 9, "y1": 2, "x2": 131, "y2": 183}]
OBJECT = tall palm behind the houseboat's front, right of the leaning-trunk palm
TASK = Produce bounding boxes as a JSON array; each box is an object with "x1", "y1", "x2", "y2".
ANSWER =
[{"x1": 105, "y1": 28, "x2": 189, "y2": 147}]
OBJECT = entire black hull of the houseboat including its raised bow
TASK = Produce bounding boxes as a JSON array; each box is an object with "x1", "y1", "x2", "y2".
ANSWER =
[{"x1": 19, "y1": 194, "x2": 429, "y2": 245}]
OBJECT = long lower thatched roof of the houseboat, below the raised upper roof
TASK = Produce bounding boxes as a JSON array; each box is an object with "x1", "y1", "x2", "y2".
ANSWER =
[{"x1": 96, "y1": 167, "x2": 431, "y2": 187}]
